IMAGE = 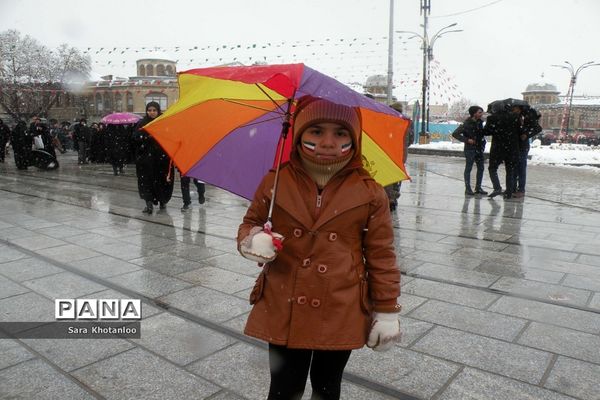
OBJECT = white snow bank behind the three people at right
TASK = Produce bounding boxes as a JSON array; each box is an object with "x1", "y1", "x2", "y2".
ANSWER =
[{"x1": 411, "y1": 140, "x2": 600, "y2": 167}]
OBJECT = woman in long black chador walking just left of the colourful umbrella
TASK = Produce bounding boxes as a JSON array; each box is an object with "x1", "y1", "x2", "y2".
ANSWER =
[{"x1": 133, "y1": 101, "x2": 174, "y2": 214}]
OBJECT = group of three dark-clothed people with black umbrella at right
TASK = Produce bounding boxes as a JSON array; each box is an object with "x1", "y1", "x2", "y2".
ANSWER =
[{"x1": 452, "y1": 101, "x2": 542, "y2": 199}]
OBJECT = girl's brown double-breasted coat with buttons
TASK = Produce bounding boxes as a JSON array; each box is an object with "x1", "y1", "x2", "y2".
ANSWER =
[{"x1": 238, "y1": 157, "x2": 400, "y2": 350}]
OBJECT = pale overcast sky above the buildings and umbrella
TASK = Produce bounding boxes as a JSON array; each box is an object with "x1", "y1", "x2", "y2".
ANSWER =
[{"x1": 0, "y1": 0, "x2": 600, "y2": 105}]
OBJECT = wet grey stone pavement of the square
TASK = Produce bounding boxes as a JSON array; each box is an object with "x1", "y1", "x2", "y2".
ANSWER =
[{"x1": 0, "y1": 153, "x2": 600, "y2": 400}]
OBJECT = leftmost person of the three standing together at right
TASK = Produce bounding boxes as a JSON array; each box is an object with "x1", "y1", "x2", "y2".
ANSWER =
[{"x1": 452, "y1": 106, "x2": 487, "y2": 196}]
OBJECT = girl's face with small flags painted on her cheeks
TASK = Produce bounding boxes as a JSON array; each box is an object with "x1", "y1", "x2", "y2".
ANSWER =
[{"x1": 300, "y1": 122, "x2": 352, "y2": 159}]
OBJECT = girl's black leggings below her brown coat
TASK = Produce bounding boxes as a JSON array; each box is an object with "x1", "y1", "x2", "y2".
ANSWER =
[{"x1": 267, "y1": 344, "x2": 351, "y2": 400}]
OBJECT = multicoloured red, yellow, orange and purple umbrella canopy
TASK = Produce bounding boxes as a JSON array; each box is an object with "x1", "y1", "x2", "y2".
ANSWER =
[{"x1": 144, "y1": 64, "x2": 410, "y2": 198}]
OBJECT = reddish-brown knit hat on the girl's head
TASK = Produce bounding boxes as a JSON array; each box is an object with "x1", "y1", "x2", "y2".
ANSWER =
[{"x1": 294, "y1": 96, "x2": 361, "y2": 149}]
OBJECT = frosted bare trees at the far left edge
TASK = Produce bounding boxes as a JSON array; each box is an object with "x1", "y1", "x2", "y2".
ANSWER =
[{"x1": 0, "y1": 30, "x2": 91, "y2": 120}]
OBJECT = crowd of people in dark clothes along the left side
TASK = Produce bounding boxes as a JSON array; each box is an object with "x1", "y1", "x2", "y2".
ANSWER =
[{"x1": 0, "y1": 106, "x2": 206, "y2": 214}]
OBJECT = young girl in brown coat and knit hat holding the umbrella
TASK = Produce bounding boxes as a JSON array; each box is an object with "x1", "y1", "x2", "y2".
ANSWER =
[{"x1": 238, "y1": 97, "x2": 400, "y2": 399}]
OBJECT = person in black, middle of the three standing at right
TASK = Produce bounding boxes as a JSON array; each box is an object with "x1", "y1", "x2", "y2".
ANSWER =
[{"x1": 484, "y1": 107, "x2": 521, "y2": 199}]
